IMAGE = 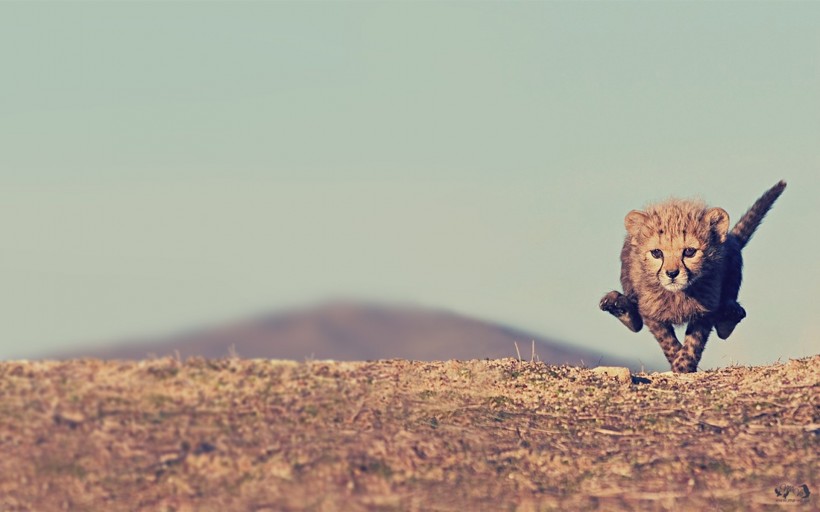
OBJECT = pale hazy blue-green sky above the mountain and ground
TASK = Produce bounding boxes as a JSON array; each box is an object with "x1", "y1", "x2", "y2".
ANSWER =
[{"x1": 0, "y1": 1, "x2": 820, "y2": 368}]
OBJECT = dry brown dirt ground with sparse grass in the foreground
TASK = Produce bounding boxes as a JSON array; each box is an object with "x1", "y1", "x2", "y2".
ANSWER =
[{"x1": 0, "y1": 356, "x2": 820, "y2": 512}]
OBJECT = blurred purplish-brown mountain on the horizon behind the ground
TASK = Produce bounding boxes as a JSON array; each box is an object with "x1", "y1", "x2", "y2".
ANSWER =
[{"x1": 58, "y1": 302, "x2": 639, "y2": 369}]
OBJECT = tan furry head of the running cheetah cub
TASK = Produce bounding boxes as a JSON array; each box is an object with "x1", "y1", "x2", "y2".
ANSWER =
[{"x1": 624, "y1": 199, "x2": 729, "y2": 292}]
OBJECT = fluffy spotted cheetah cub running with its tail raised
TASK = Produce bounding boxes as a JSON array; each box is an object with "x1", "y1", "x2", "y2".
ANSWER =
[{"x1": 600, "y1": 181, "x2": 786, "y2": 373}]
